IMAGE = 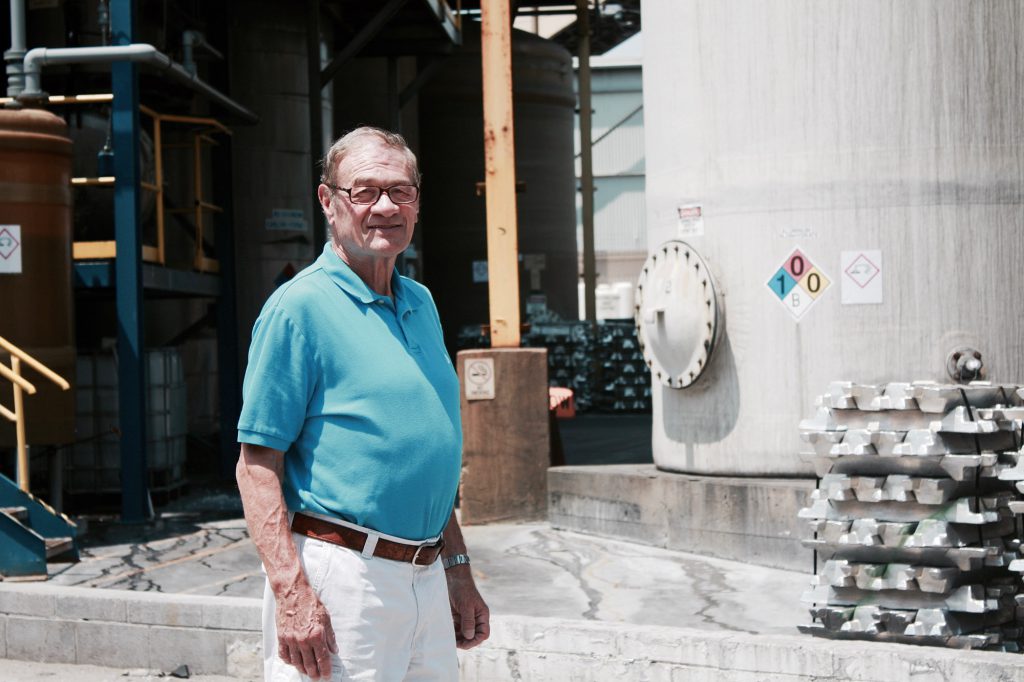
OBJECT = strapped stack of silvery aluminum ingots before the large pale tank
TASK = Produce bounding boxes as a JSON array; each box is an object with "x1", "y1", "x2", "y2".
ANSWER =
[{"x1": 800, "y1": 382, "x2": 1024, "y2": 651}]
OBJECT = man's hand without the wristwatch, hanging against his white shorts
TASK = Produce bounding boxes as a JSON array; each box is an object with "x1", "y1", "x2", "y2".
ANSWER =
[{"x1": 276, "y1": 590, "x2": 338, "y2": 680}]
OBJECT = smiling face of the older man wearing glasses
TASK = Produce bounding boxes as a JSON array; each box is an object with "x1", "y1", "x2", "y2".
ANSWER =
[{"x1": 318, "y1": 140, "x2": 420, "y2": 264}]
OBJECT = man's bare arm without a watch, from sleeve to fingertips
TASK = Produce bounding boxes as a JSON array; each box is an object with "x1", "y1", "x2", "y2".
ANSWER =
[{"x1": 236, "y1": 443, "x2": 338, "y2": 679}]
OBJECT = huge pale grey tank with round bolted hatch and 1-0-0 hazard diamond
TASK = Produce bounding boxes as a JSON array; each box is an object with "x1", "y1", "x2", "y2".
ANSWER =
[{"x1": 638, "y1": 0, "x2": 1024, "y2": 476}]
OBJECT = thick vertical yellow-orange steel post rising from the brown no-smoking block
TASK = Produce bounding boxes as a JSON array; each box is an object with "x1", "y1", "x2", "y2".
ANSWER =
[{"x1": 480, "y1": 0, "x2": 519, "y2": 348}]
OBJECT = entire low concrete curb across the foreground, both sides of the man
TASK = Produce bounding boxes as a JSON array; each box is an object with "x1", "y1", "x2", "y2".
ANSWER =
[{"x1": 0, "y1": 583, "x2": 1024, "y2": 682}]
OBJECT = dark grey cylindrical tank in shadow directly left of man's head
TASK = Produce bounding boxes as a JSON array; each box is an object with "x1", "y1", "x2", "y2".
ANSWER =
[{"x1": 228, "y1": 0, "x2": 315, "y2": 339}]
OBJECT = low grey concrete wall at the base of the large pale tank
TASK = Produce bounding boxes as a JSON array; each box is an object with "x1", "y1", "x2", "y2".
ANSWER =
[{"x1": 548, "y1": 464, "x2": 814, "y2": 572}]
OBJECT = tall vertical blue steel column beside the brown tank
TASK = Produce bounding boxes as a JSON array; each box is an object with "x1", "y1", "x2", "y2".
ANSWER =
[{"x1": 111, "y1": 0, "x2": 152, "y2": 522}]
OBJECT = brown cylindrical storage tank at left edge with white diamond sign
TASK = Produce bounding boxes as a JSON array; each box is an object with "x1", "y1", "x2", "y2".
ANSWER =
[{"x1": 0, "y1": 110, "x2": 75, "y2": 447}]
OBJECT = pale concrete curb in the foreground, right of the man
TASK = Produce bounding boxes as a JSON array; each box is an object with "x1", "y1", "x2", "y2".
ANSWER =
[{"x1": 460, "y1": 616, "x2": 1024, "y2": 682}]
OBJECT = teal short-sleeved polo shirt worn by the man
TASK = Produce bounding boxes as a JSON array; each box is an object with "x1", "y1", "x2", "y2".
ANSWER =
[{"x1": 239, "y1": 244, "x2": 462, "y2": 540}]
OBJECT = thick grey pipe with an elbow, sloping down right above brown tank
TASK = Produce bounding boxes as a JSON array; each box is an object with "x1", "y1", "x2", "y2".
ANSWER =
[{"x1": 17, "y1": 43, "x2": 259, "y2": 123}]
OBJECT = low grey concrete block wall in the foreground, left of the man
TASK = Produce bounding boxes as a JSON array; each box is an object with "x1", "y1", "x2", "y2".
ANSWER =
[{"x1": 0, "y1": 583, "x2": 262, "y2": 679}]
